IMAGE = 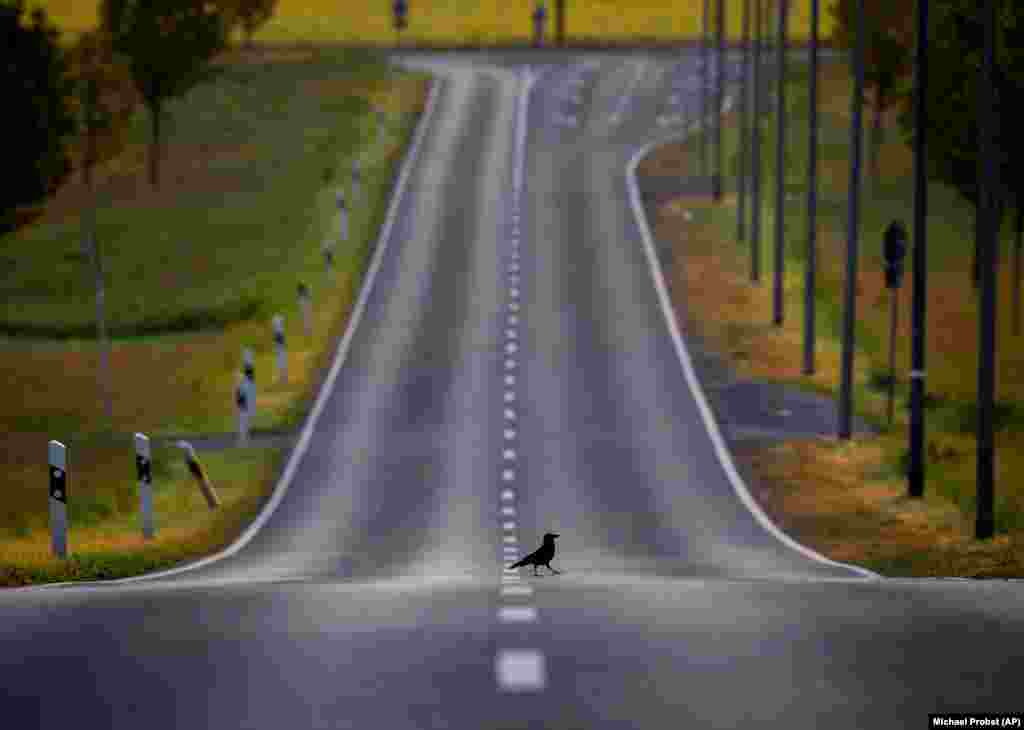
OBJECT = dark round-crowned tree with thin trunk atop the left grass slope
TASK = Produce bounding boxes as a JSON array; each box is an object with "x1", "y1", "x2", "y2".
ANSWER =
[{"x1": 100, "y1": 0, "x2": 227, "y2": 187}]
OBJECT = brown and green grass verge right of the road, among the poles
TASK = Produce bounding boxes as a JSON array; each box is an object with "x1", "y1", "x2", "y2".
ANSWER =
[{"x1": 641, "y1": 54, "x2": 1024, "y2": 576}]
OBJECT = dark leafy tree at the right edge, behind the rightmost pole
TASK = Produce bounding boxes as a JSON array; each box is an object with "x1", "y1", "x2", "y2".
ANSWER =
[{"x1": 900, "y1": 0, "x2": 1024, "y2": 287}]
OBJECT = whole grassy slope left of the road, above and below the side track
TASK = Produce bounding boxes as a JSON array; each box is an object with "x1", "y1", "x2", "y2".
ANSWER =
[{"x1": 0, "y1": 49, "x2": 428, "y2": 585}]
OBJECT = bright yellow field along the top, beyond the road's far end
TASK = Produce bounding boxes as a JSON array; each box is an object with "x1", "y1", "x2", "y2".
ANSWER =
[{"x1": 30, "y1": 0, "x2": 831, "y2": 45}]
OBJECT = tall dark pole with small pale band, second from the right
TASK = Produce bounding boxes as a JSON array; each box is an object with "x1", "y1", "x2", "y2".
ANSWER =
[{"x1": 907, "y1": 0, "x2": 929, "y2": 497}]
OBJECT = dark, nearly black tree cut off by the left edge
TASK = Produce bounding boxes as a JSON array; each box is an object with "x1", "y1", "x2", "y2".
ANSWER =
[{"x1": 0, "y1": 0, "x2": 76, "y2": 229}]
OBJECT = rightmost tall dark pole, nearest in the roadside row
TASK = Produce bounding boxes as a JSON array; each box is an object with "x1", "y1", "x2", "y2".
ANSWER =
[{"x1": 975, "y1": 0, "x2": 1000, "y2": 540}]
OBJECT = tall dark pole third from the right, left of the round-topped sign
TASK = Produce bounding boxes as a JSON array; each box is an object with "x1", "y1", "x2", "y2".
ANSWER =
[{"x1": 839, "y1": 0, "x2": 864, "y2": 439}]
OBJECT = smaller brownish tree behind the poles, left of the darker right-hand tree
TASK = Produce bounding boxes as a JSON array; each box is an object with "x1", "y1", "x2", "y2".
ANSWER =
[{"x1": 829, "y1": 0, "x2": 914, "y2": 193}]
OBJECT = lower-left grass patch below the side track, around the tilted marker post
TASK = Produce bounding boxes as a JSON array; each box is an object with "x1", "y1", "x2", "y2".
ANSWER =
[{"x1": 0, "y1": 434, "x2": 287, "y2": 587}]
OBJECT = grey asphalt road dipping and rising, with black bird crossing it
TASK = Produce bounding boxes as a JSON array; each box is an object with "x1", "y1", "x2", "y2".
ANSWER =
[{"x1": 0, "y1": 54, "x2": 1024, "y2": 730}]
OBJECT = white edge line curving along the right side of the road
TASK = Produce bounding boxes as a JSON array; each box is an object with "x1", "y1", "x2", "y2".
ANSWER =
[{"x1": 626, "y1": 87, "x2": 883, "y2": 579}]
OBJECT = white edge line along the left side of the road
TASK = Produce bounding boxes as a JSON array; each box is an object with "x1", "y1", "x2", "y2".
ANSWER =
[{"x1": 14, "y1": 72, "x2": 444, "y2": 593}]
